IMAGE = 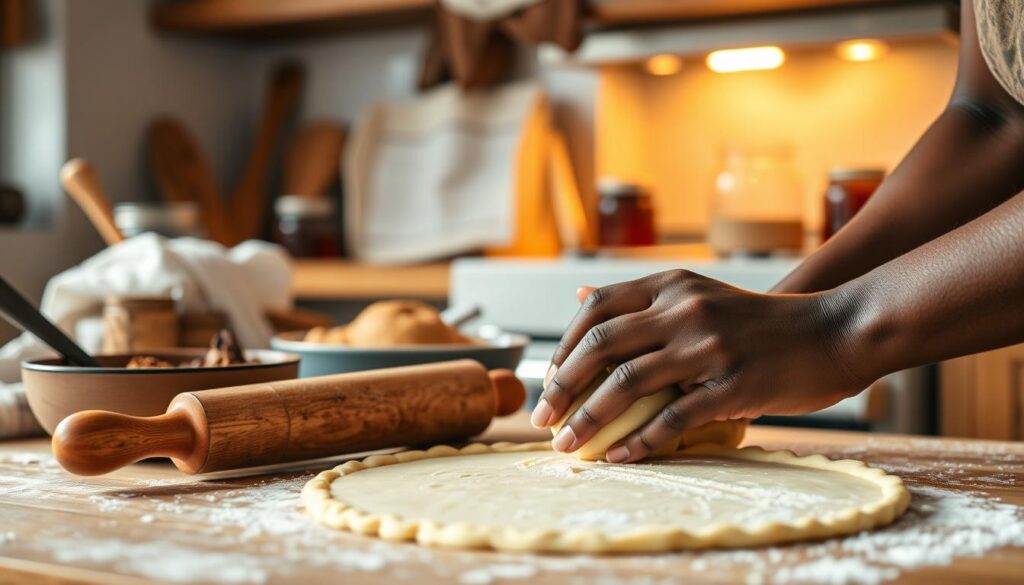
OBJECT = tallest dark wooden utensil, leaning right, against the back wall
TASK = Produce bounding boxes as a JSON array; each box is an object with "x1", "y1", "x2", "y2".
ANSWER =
[{"x1": 230, "y1": 62, "x2": 305, "y2": 241}]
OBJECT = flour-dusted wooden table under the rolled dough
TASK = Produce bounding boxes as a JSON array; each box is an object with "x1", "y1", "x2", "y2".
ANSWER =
[{"x1": 0, "y1": 416, "x2": 1024, "y2": 585}]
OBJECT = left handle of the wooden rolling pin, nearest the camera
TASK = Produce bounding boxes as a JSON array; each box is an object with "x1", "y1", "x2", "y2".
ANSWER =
[{"x1": 52, "y1": 409, "x2": 197, "y2": 475}]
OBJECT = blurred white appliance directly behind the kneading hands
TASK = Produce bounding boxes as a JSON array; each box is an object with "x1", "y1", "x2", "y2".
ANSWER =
[{"x1": 449, "y1": 258, "x2": 932, "y2": 433}]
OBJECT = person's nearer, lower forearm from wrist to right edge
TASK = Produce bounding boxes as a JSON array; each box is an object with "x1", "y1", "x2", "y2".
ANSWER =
[{"x1": 823, "y1": 194, "x2": 1024, "y2": 380}]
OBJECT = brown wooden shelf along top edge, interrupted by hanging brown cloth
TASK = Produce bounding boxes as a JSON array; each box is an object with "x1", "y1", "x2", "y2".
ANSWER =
[{"x1": 152, "y1": 0, "x2": 907, "y2": 38}]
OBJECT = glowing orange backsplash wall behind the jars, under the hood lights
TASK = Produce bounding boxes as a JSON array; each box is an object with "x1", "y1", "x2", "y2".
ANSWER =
[{"x1": 595, "y1": 39, "x2": 957, "y2": 237}]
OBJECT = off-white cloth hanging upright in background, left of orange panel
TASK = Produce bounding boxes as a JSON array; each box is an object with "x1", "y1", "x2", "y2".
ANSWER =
[{"x1": 344, "y1": 82, "x2": 543, "y2": 263}]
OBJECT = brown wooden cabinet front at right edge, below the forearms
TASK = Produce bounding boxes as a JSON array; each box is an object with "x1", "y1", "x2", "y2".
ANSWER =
[{"x1": 939, "y1": 344, "x2": 1024, "y2": 441}]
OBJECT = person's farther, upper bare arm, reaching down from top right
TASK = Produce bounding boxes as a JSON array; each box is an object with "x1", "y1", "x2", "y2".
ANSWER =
[{"x1": 772, "y1": 2, "x2": 1024, "y2": 293}]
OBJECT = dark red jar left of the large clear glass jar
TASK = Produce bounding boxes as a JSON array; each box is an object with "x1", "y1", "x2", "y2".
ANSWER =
[{"x1": 597, "y1": 178, "x2": 655, "y2": 246}]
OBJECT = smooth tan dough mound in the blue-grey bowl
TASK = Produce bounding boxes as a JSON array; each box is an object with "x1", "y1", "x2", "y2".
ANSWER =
[{"x1": 346, "y1": 300, "x2": 467, "y2": 347}]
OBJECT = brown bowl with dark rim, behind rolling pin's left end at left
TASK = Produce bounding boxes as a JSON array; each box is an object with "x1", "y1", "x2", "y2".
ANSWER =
[{"x1": 22, "y1": 348, "x2": 299, "y2": 434}]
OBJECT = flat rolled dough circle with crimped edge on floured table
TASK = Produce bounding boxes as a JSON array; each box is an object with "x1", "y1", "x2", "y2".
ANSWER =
[{"x1": 302, "y1": 443, "x2": 910, "y2": 552}]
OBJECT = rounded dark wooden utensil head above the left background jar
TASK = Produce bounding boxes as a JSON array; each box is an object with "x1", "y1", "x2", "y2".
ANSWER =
[{"x1": 284, "y1": 121, "x2": 345, "y2": 197}]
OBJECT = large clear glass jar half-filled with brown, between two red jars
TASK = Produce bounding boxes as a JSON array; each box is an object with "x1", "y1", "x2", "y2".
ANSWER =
[{"x1": 708, "y1": 144, "x2": 804, "y2": 256}]
